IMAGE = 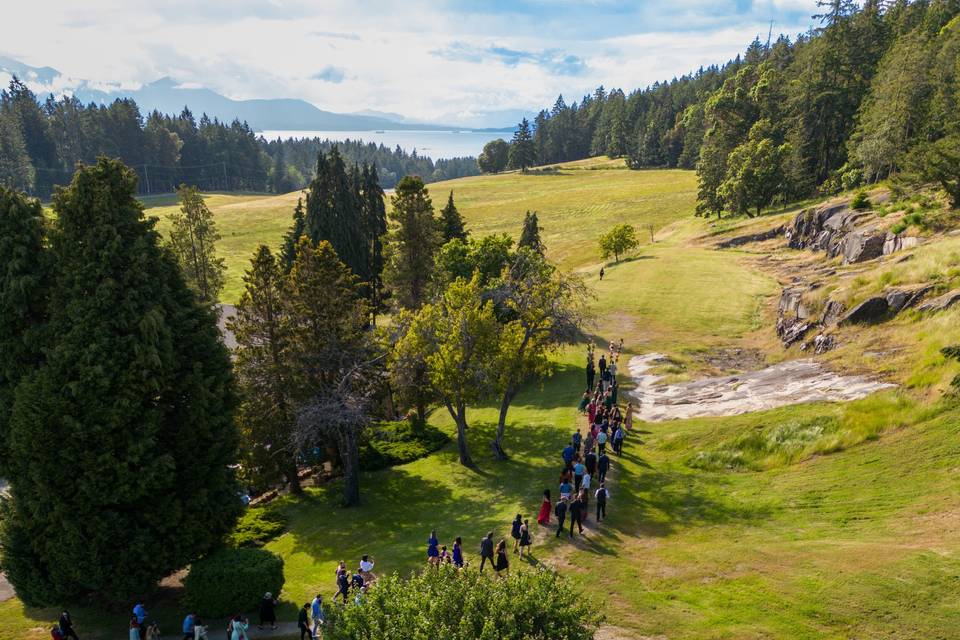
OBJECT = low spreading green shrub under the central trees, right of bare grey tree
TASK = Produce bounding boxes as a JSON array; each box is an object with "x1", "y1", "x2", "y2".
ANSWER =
[{"x1": 360, "y1": 420, "x2": 449, "y2": 471}]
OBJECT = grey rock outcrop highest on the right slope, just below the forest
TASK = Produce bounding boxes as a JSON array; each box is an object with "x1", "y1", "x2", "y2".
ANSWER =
[{"x1": 786, "y1": 203, "x2": 920, "y2": 264}]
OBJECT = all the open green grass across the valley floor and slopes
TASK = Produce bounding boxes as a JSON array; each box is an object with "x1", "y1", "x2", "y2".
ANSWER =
[{"x1": 7, "y1": 161, "x2": 960, "y2": 640}]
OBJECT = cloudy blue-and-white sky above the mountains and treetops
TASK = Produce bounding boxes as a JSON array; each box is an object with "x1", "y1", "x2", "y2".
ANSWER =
[{"x1": 0, "y1": 0, "x2": 816, "y2": 123}]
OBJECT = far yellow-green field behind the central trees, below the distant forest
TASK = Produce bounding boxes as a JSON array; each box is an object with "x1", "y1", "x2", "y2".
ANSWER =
[{"x1": 145, "y1": 159, "x2": 696, "y2": 302}]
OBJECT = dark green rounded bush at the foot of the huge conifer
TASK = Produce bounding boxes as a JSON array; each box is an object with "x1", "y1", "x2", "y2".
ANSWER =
[{"x1": 183, "y1": 548, "x2": 283, "y2": 618}]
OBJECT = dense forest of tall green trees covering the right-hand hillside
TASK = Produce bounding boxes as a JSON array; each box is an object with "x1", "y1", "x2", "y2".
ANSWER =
[{"x1": 478, "y1": 0, "x2": 960, "y2": 215}]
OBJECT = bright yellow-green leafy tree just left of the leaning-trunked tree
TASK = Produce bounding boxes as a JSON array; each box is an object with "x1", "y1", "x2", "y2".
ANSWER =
[{"x1": 395, "y1": 276, "x2": 500, "y2": 466}]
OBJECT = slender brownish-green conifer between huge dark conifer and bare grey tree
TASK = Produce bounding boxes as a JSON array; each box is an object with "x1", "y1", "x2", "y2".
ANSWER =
[{"x1": 230, "y1": 245, "x2": 302, "y2": 493}]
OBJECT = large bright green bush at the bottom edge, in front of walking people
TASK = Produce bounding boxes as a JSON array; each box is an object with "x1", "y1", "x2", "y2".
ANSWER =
[{"x1": 325, "y1": 566, "x2": 602, "y2": 640}]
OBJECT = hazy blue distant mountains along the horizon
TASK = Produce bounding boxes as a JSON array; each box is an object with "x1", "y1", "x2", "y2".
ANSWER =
[{"x1": 0, "y1": 56, "x2": 530, "y2": 131}]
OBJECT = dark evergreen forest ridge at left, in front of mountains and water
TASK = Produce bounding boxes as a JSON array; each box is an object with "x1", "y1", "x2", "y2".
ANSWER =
[{"x1": 0, "y1": 83, "x2": 479, "y2": 198}]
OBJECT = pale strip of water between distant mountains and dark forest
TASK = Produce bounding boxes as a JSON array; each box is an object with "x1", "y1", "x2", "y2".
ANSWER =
[{"x1": 260, "y1": 130, "x2": 512, "y2": 160}]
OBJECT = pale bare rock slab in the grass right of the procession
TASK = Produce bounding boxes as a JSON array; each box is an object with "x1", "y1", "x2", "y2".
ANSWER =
[{"x1": 629, "y1": 353, "x2": 895, "y2": 422}]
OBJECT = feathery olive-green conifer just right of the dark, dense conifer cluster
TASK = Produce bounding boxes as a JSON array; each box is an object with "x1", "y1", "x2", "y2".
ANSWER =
[{"x1": 384, "y1": 176, "x2": 441, "y2": 309}]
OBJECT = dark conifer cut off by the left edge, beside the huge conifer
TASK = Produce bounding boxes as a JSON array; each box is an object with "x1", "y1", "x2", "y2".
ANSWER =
[{"x1": 0, "y1": 187, "x2": 49, "y2": 475}]
